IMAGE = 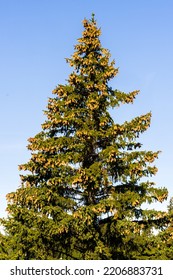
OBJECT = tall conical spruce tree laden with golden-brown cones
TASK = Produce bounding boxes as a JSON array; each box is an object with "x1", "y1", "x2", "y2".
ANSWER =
[{"x1": 2, "y1": 15, "x2": 168, "y2": 260}]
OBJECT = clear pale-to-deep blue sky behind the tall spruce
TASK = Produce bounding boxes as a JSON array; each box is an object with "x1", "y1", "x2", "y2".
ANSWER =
[{"x1": 0, "y1": 0, "x2": 173, "y2": 217}]
